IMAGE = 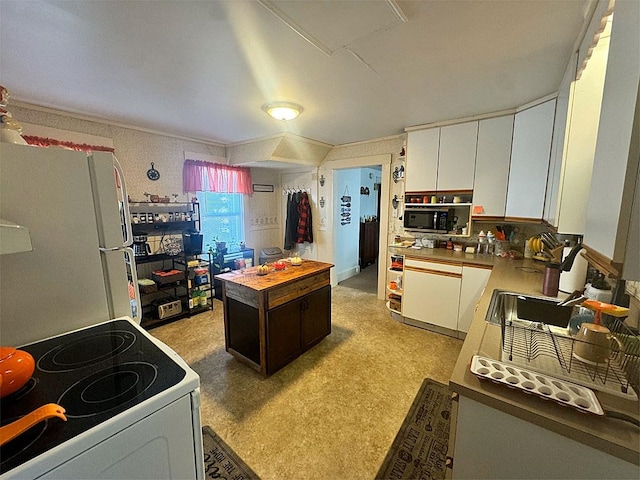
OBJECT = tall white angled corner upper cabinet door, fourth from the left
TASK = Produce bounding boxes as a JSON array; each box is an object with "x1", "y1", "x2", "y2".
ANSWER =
[{"x1": 506, "y1": 99, "x2": 556, "y2": 219}]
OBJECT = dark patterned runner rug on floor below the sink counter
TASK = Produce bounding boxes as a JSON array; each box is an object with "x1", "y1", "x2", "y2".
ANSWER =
[{"x1": 376, "y1": 378, "x2": 451, "y2": 480}]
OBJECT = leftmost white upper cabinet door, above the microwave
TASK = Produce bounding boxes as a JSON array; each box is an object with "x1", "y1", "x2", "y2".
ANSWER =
[{"x1": 404, "y1": 128, "x2": 440, "y2": 192}]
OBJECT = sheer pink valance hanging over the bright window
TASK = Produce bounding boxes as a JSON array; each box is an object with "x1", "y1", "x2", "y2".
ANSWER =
[{"x1": 182, "y1": 160, "x2": 252, "y2": 194}]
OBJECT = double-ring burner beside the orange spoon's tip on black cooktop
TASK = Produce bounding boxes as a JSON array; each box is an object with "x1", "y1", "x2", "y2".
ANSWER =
[{"x1": 56, "y1": 362, "x2": 158, "y2": 418}]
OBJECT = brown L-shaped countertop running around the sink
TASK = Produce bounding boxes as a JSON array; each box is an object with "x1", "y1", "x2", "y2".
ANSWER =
[{"x1": 389, "y1": 247, "x2": 640, "y2": 465}]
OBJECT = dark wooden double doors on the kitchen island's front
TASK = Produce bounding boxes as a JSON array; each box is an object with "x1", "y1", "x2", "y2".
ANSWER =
[{"x1": 266, "y1": 286, "x2": 331, "y2": 375}]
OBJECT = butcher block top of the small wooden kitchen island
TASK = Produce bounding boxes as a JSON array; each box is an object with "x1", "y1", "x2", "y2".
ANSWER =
[{"x1": 216, "y1": 260, "x2": 333, "y2": 291}]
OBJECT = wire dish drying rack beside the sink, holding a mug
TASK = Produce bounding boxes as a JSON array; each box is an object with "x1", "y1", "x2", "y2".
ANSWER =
[{"x1": 501, "y1": 315, "x2": 640, "y2": 400}]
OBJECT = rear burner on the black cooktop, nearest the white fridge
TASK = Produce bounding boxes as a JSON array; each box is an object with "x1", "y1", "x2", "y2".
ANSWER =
[{"x1": 37, "y1": 330, "x2": 136, "y2": 372}]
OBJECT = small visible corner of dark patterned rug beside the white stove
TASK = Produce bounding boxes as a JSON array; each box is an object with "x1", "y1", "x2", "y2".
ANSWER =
[{"x1": 202, "y1": 425, "x2": 260, "y2": 480}]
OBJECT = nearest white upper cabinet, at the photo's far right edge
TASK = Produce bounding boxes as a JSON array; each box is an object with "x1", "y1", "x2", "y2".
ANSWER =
[{"x1": 584, "y1": 2, "x2": 640, "y2": 280}]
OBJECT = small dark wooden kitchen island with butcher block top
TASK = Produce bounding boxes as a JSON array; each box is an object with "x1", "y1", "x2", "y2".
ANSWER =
[{"x1": 216, "y1": 260, "x2": 333, "y2": 376}]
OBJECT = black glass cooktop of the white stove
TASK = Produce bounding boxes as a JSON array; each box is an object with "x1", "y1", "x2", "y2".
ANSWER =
[{"x1": 0, "y1": 320, "x2": 186, "y2": 474}]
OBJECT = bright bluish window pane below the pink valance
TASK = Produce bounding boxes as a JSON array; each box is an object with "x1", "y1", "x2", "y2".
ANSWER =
[{"x1": 197, "y1": 192, "x2": 244, "y2": 248}]
